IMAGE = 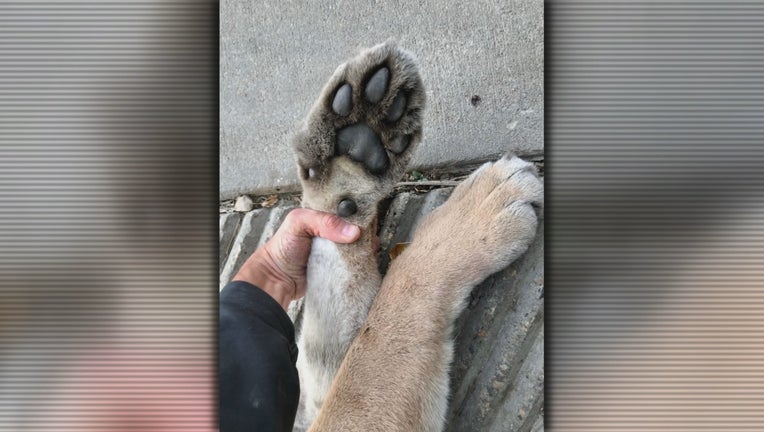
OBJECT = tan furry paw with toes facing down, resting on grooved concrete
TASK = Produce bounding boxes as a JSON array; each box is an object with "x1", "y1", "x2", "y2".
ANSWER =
[{"x1": 410, "y1": 157, "x2": 544, "y2": 286}]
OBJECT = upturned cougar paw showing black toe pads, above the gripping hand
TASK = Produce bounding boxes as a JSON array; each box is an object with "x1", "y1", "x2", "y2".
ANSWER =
[{"x1": 294, "y1": 41, "x2": 425, "y2": 226}]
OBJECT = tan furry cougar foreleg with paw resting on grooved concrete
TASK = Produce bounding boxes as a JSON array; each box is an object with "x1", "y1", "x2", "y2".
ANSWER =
[{"x1": 310, "y1": 158, "x2": 543, "y2": 431}]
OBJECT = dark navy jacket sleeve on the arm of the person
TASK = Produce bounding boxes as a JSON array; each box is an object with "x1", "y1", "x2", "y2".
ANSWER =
[{"x1": 219, "y1": 281, "x2": 300, "y2": 432}]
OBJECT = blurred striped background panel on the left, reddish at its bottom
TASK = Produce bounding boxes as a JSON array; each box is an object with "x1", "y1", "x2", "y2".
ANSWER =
[{"x1": 0, "y1": 1, "x2": 218, "y2": 431}]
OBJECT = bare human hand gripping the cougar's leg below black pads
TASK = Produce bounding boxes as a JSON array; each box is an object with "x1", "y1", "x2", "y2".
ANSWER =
[{"x1": 233, "y1": 208, "x2": 361, "y2": 310}]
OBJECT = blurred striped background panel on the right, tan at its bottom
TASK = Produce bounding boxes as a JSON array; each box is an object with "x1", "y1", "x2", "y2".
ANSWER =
[{"x1": 545, "y1": 1, "x2": 764, "y2": 431}]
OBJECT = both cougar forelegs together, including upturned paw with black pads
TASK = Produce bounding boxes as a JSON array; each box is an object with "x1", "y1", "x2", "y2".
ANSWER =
[{"x1": 293, "y1": 41, "x2": 543, "y2": 432}]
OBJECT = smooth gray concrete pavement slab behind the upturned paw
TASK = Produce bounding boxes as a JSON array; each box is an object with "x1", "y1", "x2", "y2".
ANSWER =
[{"x1": 220, "y1": 0, "x2": 544, "y2": 199}]
